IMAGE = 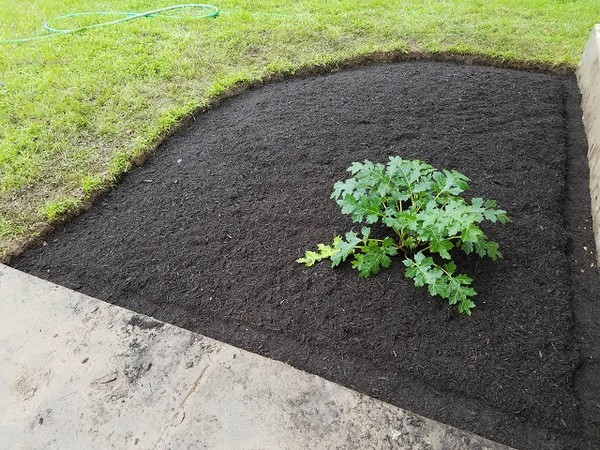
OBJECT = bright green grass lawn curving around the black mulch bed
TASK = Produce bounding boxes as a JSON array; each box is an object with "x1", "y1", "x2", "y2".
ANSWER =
[{"x1": 0, "y1": 0, "x2": 600, "y2": 261}]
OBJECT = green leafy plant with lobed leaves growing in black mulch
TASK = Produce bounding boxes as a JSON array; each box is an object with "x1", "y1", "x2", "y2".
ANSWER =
[{"x1": 297, "y1": 156, "x2": 509, "y2": 315}]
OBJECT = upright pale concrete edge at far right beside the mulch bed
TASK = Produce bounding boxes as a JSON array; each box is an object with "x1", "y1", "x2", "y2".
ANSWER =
[{"x1": 577, "y1": 24, "x2": 600, "y2": 263}]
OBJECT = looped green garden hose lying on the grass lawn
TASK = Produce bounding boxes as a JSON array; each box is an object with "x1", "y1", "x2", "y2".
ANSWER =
[{"x1": 0, "y1": 3, "x2": 220, "y2": 44}]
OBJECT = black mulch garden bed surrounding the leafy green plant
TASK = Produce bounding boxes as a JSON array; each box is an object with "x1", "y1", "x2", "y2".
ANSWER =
[{"x1": 14, "y1": 61, "x2": 600, "y2": 449}]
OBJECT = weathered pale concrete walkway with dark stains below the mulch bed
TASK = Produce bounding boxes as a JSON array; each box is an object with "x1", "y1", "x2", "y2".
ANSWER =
[{"x1": 0, "y1": 265, "x2": 507, "y2": 450}]
